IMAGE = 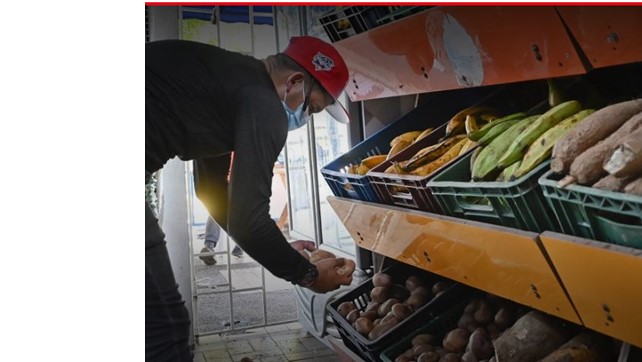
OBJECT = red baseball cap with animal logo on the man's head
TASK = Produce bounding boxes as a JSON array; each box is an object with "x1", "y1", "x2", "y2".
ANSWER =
[{"x1": 283, "y1": 36, "x2": 350, "y2": 123}]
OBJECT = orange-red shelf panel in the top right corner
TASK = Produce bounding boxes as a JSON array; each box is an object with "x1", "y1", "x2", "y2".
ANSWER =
[{"x1": 557, "y1": 6, "x2": 642, "y2": 68}]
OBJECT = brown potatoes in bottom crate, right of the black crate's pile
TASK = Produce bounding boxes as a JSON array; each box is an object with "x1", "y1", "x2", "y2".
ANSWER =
[{"x1": 395, "y1": 294, "x2": 526, "y2": 362}]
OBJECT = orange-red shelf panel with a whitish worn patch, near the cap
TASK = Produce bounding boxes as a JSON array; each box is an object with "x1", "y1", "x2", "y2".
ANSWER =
[{"x1": 334, "y1": 6, "x2": 586, "y2": 101}]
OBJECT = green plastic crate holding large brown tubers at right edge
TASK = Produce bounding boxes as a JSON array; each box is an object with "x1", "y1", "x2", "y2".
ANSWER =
[{"x1": 539, "y1": 171, "x2": 642, "y2": 249}]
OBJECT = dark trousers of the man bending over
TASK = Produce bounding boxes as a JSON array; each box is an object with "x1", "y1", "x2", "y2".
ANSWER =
[{"x1": 145, "y1": 202, "x2": 193, "y2": 362}]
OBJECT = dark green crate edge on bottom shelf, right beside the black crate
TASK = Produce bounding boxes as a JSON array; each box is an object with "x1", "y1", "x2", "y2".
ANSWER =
[{"x1": 379, "y1": 302, "x2": 468, "y2": 362}]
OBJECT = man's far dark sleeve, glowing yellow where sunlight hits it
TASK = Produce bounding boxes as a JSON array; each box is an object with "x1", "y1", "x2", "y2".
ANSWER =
[{"x1": 194, "y1": 154, "x2": 230, "y2": 231}]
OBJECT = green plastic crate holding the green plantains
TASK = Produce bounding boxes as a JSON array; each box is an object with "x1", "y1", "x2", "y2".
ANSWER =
[{"x1": 427, "y1": 154, "x2": 559, "y2": 232}]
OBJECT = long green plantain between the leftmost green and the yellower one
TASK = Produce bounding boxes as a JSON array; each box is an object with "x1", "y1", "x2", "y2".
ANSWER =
[{"x1": 498, "y1": 101, "x2": 582, "y2": 169}]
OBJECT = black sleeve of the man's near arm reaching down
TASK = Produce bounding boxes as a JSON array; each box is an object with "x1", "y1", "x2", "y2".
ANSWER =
[{"x1": 228, "y1": 88, "x2": 310, "y2": 281}]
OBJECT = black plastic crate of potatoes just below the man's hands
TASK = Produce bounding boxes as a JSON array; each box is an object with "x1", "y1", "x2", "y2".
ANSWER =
[{"x1": 327, "y1": 263, "x2": 475, "y2": 361}]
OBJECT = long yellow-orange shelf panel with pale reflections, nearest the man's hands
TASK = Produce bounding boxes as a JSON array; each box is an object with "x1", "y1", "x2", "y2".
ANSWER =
[{"x1": 328, "y1": 196, "x2": 582, "y2": 324}]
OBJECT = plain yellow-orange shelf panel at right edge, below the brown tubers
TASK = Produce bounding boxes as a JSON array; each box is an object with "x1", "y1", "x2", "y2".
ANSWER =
[{"x1": 540, "y1": 232, "x2": 642, "y2": 347}]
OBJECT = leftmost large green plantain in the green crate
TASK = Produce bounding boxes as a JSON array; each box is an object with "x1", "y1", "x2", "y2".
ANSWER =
[{"x1": 471, "y1": 115, "x2": 541, "y2": 181}]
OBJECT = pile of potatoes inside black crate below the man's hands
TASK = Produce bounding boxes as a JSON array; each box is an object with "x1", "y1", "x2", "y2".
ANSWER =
[{"x1": 337, "y1": 272, "x2": 452, "y2": 340}]
